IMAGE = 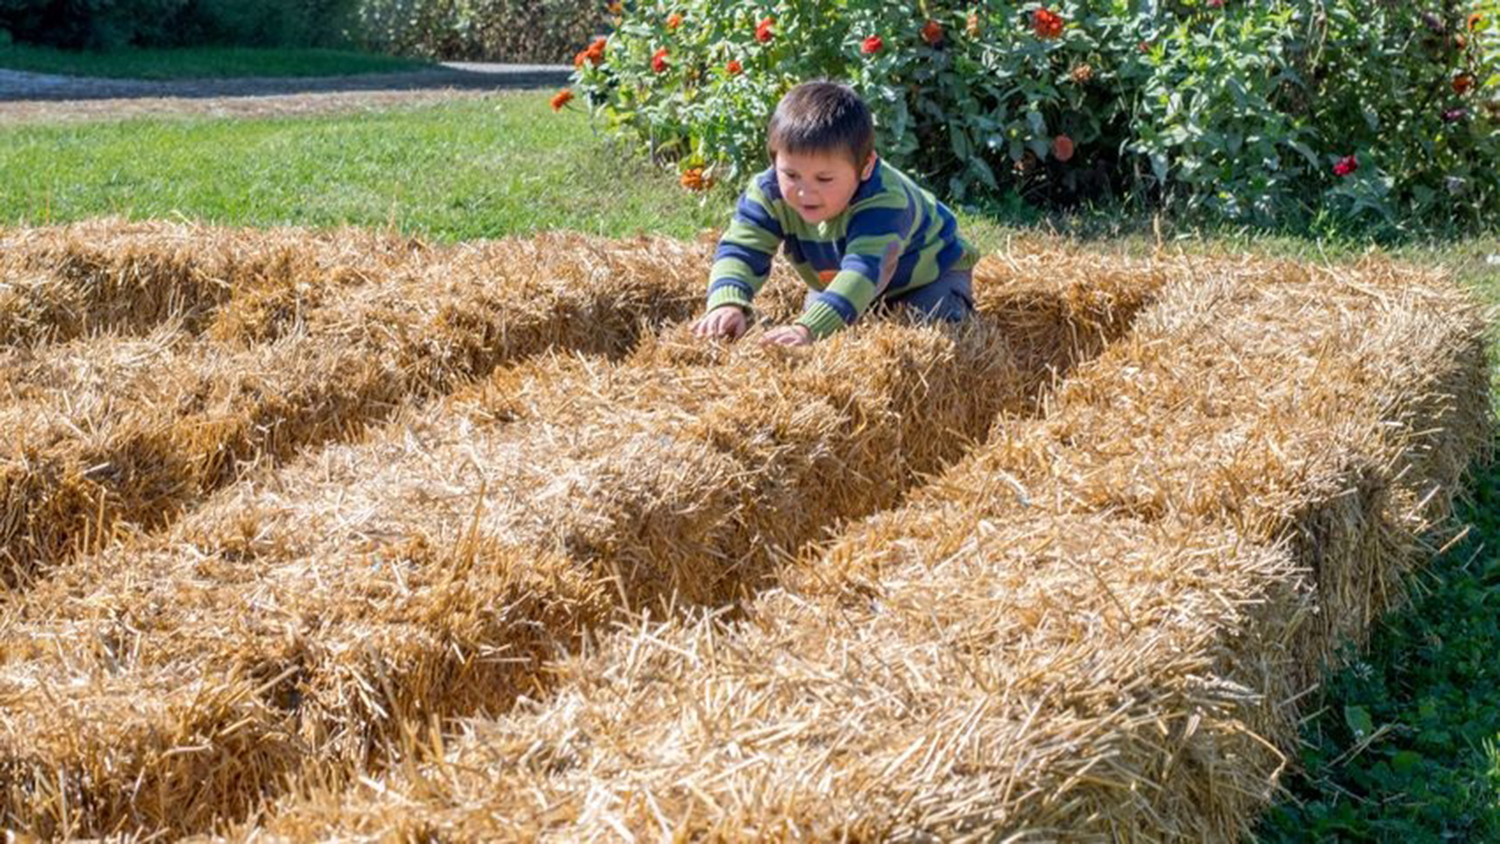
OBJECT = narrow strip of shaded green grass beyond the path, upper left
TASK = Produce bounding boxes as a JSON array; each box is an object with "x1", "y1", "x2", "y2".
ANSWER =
[{"x1": 0, "y1": 43, "x2": 431, "y2": 79}]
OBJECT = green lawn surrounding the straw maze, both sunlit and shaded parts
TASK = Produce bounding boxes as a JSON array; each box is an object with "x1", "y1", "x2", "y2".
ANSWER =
[{"x1": 0, "y1": 93, "x2": 1500, "y2": 843}]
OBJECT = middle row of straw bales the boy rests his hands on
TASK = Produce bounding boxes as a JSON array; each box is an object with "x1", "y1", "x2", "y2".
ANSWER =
[{"x1": 0, "y1": 244, "x2": 1166, "y2": 835}]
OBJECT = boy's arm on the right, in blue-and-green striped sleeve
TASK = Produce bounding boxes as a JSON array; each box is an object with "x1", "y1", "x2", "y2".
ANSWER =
[{"x1": 797, "y1": 190, "x2": 917, "y2": 339}]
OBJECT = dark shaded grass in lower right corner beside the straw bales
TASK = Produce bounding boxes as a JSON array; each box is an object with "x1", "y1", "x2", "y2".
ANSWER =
[{"x1": 1253, "y1": 438, "x2": 1500, "y2": 843}]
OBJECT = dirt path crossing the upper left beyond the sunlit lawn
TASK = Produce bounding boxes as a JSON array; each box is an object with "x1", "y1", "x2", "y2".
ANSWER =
[{"x1": 0, "y1": 63, "x2": 572, "y2": 124}]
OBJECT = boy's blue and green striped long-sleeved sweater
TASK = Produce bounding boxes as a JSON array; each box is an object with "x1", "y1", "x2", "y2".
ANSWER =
[{"x1": 708, "y1": 159, "x2": 975, "y2": 337}]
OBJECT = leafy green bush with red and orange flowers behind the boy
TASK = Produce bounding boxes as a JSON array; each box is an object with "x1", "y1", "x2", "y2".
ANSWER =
[{"x1": 555, "y1": 0, "x2": 1500, "y2": 228}]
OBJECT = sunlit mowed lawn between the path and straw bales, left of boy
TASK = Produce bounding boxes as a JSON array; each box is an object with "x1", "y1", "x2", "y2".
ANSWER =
[{"x1": 0, "y1": 93, "x2": 728, "y2": 241}]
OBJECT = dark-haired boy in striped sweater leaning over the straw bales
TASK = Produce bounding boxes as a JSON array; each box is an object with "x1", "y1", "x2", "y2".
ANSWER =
[{"x1": 693, "y1": 81, "x2": 975, "y2": 346}]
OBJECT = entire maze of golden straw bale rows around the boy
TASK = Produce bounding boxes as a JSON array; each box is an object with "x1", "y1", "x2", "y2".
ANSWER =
[{"x1": 0, "y1": 223, "x2": 1487, "y2": 840}]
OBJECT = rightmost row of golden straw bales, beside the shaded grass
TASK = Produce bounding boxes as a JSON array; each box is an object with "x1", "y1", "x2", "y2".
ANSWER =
[{"x1": 255, "y1": 261, "x2": 1491, "y2": 841}]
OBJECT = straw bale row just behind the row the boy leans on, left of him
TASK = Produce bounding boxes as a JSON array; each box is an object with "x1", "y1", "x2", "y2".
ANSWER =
[{"x1": 0, "y1": 232, "x2": 701, "y2": 588}]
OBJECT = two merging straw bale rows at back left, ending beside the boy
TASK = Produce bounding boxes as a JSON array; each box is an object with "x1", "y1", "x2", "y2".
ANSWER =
[{"x1": 0, "y1": 223, "x2": 707, "y2": 588}]
